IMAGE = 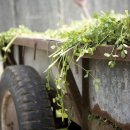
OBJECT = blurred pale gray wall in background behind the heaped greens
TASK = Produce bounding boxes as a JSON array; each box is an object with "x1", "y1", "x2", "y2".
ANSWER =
[{"x1": 0, "y1": 0, "x2": 130, "y2": 31}]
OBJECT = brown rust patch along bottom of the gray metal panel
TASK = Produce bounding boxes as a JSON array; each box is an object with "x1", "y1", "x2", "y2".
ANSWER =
[{"x1": 90, "y1": 104, "x2": 130, "y2": 130}]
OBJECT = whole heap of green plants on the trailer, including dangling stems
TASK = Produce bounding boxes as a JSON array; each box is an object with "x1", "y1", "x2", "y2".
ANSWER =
[{"x1": 0, "y1": 11, "x2": 130, "y2": 123}]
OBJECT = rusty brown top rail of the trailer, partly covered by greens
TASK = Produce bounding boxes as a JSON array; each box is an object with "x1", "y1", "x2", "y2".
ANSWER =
[{"x1": 14, "y1": 37, "x2": 130, "y2": 61}]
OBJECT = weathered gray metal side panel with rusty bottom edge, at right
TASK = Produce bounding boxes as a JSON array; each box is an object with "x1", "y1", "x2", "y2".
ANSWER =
[{"x1": 89, "y1": 60, "x2": 130, "y2": 130}]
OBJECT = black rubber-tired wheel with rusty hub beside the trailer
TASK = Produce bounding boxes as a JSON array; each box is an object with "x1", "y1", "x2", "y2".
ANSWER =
[{"x1": 0, "y1": 66, "x2": 55, "y2": 130}]
